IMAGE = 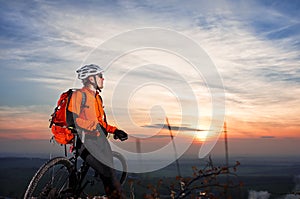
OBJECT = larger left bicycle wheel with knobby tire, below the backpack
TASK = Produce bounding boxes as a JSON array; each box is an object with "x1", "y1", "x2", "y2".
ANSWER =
[{"x1": 24, "y1": 157, "x2": 74, "y2": 199}]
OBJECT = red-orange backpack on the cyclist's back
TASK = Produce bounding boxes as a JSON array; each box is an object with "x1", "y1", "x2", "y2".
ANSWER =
[{"x1": 49, "y1": 89, "x2": 86, "y2": 144}]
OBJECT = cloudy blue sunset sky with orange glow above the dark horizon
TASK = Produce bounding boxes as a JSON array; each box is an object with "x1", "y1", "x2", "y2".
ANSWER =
[{"x1": 0, "y1": 0, "x2": 300, "y2": 159}]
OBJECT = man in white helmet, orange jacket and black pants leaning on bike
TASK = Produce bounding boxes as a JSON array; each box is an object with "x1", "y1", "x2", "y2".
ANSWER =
[{"x1": 67, "y1": 64, "x2": 128, "y2": 198}]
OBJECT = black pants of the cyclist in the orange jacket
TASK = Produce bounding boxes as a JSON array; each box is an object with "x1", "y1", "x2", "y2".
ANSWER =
[{"x1": 77, "y1": 136, "x2": 124, "y2": 199}]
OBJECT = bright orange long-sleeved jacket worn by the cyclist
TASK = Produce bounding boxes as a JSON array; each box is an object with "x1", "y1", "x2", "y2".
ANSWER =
[{"x1": 68, "y1": 87, "x2": 117, "y2": 133}]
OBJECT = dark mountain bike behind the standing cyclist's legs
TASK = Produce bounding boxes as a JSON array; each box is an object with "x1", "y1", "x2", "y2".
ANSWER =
[{"x1": 24, "y1": 133, "x2": 127, "y2": 199}]
